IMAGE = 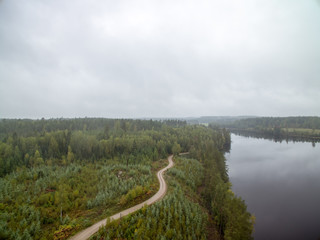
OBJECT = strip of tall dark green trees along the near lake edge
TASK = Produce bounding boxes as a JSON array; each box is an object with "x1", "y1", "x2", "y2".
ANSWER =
[{"x1": 190, "y1": 130, "x2": 255, "y2": 240}]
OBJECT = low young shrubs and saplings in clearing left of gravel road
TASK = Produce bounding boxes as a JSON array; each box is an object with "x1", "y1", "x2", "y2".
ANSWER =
[{"x1": 0, "y1": 164, "x2": 153, "y2": 239}]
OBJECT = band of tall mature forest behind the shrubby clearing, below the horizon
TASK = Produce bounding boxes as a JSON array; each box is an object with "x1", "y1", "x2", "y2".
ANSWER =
[{"x1": 0, "y1": 118, "x2": 188, "y2": 176}]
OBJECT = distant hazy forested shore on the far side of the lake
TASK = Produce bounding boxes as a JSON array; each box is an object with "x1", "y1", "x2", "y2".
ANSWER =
[{"x1": 217, "y1": 117, "x2": 320, "y2": 141}]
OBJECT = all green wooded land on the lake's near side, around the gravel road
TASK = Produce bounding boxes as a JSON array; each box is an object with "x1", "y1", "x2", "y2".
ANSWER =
[{"x1": 0, "y1": 118, "x2": 253, "y2": 239}]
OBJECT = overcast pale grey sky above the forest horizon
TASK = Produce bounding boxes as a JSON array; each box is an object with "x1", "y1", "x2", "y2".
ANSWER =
[{"x1": 0, "y1": 0, "x2": 320, "y2": 119}]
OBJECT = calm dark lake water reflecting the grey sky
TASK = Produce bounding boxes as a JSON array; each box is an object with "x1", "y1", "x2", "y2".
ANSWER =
[{"x1": 226, "y1": 134, "x2": 320, "y2": 240}]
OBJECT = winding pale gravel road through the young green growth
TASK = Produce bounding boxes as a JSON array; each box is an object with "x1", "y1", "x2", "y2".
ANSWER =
[{"x1": 70, "y1": 155, "x2": 174, "y2": 240}]
